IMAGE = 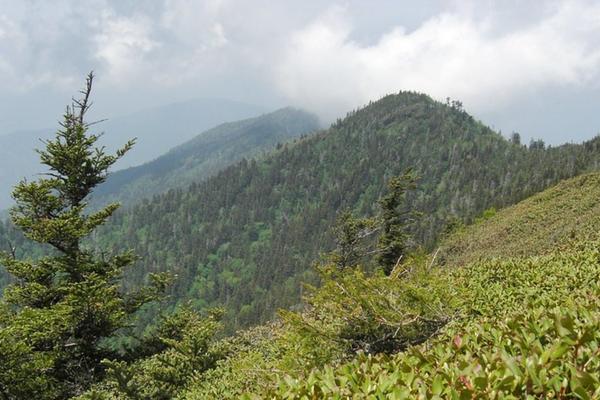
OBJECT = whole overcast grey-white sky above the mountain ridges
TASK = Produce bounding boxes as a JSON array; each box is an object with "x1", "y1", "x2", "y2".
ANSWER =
[{"x1": 0, "y1": 0, "x2": 600, "y2": 144}]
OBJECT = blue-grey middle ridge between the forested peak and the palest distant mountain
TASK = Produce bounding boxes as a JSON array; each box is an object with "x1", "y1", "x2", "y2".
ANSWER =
[{"x1": 93, "y1": 108, "x2": 319, "y2": 204}]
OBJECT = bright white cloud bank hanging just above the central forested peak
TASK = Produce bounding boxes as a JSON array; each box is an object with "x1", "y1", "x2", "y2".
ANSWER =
[{"x1": 275, "y1": 2, "x2": 600, "y2": 118}]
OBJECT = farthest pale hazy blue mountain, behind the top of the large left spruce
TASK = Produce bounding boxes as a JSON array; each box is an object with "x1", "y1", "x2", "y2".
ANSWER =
[{"x1": 0, "y1": 99, "x2": 265, "y2": 209}]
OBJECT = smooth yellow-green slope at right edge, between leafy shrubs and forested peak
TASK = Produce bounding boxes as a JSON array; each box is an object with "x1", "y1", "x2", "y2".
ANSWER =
[{"x1": 438, "y1": 173, "x2": 600, "y2": 265}]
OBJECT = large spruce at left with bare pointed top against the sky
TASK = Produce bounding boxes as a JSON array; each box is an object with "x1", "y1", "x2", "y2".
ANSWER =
[{"x1": 0, "y1": 73, "x2": 168, "y2": 399}]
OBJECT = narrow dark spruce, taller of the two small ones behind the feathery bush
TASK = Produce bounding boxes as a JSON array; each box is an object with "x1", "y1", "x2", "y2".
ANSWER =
[{"x1": 377, "y1": 169, "x2": 416, "y2": 275}]
